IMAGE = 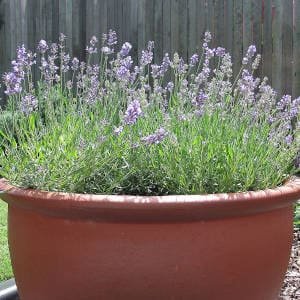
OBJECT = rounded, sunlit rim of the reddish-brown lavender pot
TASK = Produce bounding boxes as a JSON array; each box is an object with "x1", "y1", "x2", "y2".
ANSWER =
[{"x1": 0, "y1": 177, "x2": 300, "y2": 222}]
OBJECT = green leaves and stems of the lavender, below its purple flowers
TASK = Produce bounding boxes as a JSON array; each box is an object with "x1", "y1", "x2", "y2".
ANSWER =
[{"x1": 0, "y1": 89, "x2": 296, "y2": 195}]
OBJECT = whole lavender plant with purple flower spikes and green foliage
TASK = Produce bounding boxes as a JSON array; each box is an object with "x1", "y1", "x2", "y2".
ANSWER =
[{"x1": 0, "y1": 30, "x2": 300, "y2": 195}]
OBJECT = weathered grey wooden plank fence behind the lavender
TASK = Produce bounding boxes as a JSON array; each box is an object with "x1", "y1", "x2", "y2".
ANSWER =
[{"x1": 0, "y1": 0, "x2": 300, "y2": 96}]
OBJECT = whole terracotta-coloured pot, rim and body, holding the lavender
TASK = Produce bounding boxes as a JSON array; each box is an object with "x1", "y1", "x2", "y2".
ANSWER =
[{"x1": 0, "y1": 180, "x2": 300, "y2": 300}]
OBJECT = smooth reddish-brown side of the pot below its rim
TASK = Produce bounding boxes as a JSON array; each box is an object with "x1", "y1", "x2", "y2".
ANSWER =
[{"x1": 9, "y1": 206, "x2": 293, "y2": 300}]
